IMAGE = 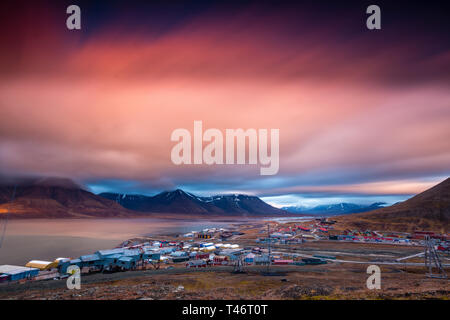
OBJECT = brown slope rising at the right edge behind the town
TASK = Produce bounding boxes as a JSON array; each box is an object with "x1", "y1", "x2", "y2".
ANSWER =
[{"x1": 337, "y1": 178, "x2": 450, "y2": 233}]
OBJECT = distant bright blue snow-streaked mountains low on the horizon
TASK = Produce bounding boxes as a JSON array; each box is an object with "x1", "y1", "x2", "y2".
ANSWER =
[{"x1": 281, "y1": 202, "x2": 386, "y2": 216}]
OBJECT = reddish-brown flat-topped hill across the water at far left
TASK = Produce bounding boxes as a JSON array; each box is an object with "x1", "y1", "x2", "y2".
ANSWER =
[{"x1": 0, "y1": 178, "x2": 136, "y2": 218}]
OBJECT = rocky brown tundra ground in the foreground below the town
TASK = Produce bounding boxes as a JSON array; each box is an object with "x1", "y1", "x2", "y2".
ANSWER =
[{"x1": 0, "y1": 264, "x2": 450, "y2": 300}]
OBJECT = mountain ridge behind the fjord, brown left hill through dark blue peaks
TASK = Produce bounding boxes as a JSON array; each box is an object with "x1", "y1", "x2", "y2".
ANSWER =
[{"x1": 0, "y1": 178, "x2": 287, "y2": 218}]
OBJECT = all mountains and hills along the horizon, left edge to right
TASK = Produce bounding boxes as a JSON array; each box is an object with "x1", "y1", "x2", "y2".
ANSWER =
[{"x1": 0, "y1": 178, "x2": 450, "y2": 232}]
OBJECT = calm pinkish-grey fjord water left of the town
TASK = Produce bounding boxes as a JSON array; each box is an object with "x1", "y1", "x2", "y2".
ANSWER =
[{"x1": 0, "y1": 218, "x2": 237, "y2": 265}]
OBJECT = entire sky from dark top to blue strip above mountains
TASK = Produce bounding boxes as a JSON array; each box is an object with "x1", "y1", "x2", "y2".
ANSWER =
[{"x1": 0, "y1": 0, "x2": 450, "y2": 206}]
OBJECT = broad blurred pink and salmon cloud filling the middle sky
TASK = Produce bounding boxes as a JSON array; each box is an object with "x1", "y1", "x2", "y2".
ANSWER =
[{"x1": 0, "y1": 5, "x2": 450, "y2": 193}]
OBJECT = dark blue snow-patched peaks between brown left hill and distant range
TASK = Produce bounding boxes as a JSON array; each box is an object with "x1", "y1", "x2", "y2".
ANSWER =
[{"x1": 100, "y1": 189, "x2": 287, "y2": 216}]
